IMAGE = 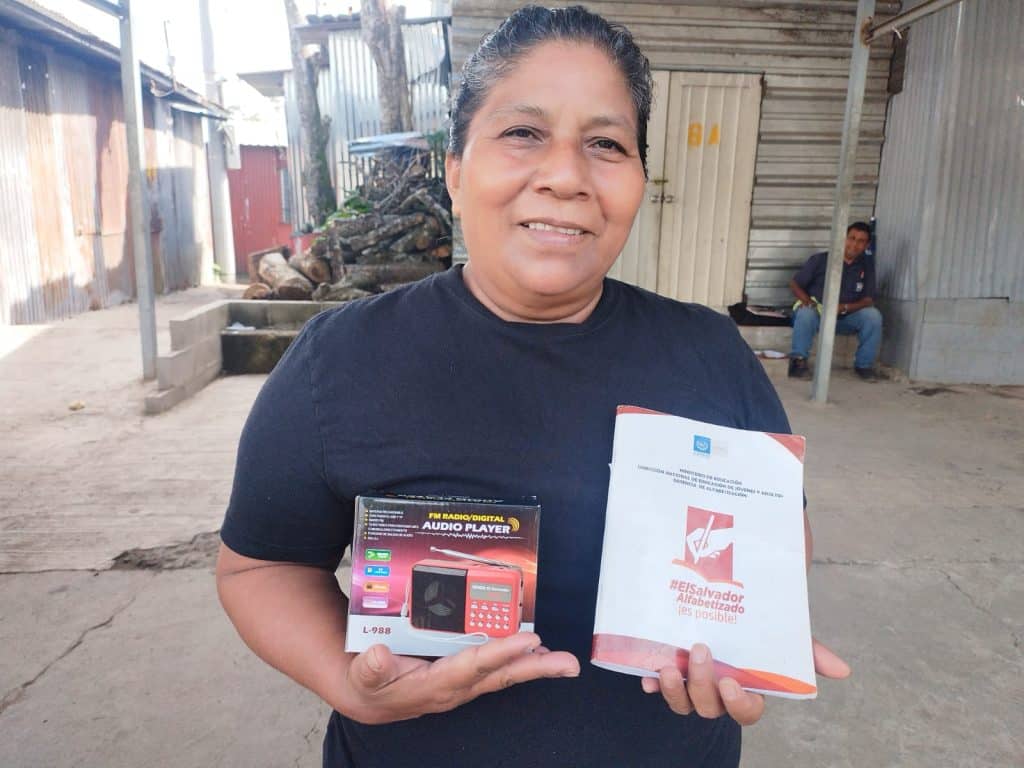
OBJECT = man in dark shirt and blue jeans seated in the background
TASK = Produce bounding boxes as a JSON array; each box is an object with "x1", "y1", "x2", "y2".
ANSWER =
[{"x1": 790, "y1": 221, "x2": 882, "y2": 381}]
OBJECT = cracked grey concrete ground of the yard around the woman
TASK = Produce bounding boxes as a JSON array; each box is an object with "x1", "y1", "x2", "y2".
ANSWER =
[{"x1": 0, "y1": 289, "x2": 1024, "y2": 768}]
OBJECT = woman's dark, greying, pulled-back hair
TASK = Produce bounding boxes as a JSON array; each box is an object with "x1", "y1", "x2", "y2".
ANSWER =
[{"x1": 449, "y1": 5, "x2": 654, "y2": 173}]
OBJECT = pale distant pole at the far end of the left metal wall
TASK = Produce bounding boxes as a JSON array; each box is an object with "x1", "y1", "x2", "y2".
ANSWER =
[{"x1": 199, "y1": 0, "x2": 234, "y2": 283}]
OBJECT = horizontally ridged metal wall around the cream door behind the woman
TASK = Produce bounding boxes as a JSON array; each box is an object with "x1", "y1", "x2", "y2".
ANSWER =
[{"x1": 452, "y1": 0, "x2": 899, "y2": 304}]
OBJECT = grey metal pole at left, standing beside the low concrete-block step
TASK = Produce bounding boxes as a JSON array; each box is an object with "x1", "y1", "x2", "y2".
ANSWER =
[{"x1": 121, "y1": 0, "x2": 157, "y2": 380}]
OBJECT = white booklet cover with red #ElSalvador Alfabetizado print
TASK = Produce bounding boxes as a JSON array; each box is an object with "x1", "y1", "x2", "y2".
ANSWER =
[{"x1": 591, "y1": 406, "x2": 817, "y2": 698}]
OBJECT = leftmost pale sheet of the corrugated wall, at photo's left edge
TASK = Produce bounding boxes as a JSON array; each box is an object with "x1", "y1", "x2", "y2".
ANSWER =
[{"x1": 0, "y1": 40, "x2": 45, "y2": 325}]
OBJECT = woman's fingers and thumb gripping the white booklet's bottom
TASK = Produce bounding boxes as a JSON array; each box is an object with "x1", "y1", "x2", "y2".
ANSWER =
[{"x1": 641, "y1": 640, "x2": 850, "y2": 725}]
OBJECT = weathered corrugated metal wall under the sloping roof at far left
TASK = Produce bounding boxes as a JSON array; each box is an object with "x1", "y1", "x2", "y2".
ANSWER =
[{"x1": 0, "y1": 31, "x2": 212, "y2": 324}]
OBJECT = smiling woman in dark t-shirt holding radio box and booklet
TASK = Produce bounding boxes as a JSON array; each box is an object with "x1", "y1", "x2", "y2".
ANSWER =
[{"x1": 217, "y1": 6, "x2": 847, "y2": 768}]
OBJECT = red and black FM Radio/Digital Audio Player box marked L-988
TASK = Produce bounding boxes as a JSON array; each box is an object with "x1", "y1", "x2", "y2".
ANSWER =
[{"x1": 345, "y1": 496, "x2": 541, "y2": 656}]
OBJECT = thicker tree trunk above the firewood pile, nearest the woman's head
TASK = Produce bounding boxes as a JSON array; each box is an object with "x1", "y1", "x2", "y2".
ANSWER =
[{"x1": 358, "y1": 0, "x2": 413, "y2": 133}]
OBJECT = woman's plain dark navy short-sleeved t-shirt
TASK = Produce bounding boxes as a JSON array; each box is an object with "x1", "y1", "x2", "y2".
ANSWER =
[{"x1": 221, "y1": 267, "x2": 790, "y2": 768}]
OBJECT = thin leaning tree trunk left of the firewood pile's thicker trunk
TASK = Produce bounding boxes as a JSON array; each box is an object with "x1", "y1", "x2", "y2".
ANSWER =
[{"x1": 285, "y1": 0, "x2": 338, "y2": 225}]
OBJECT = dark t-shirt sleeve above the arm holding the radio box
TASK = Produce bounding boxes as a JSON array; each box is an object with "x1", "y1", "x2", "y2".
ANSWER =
[{"x1": 220, "y1": 317, "x2": 352, "y2": 569}]
